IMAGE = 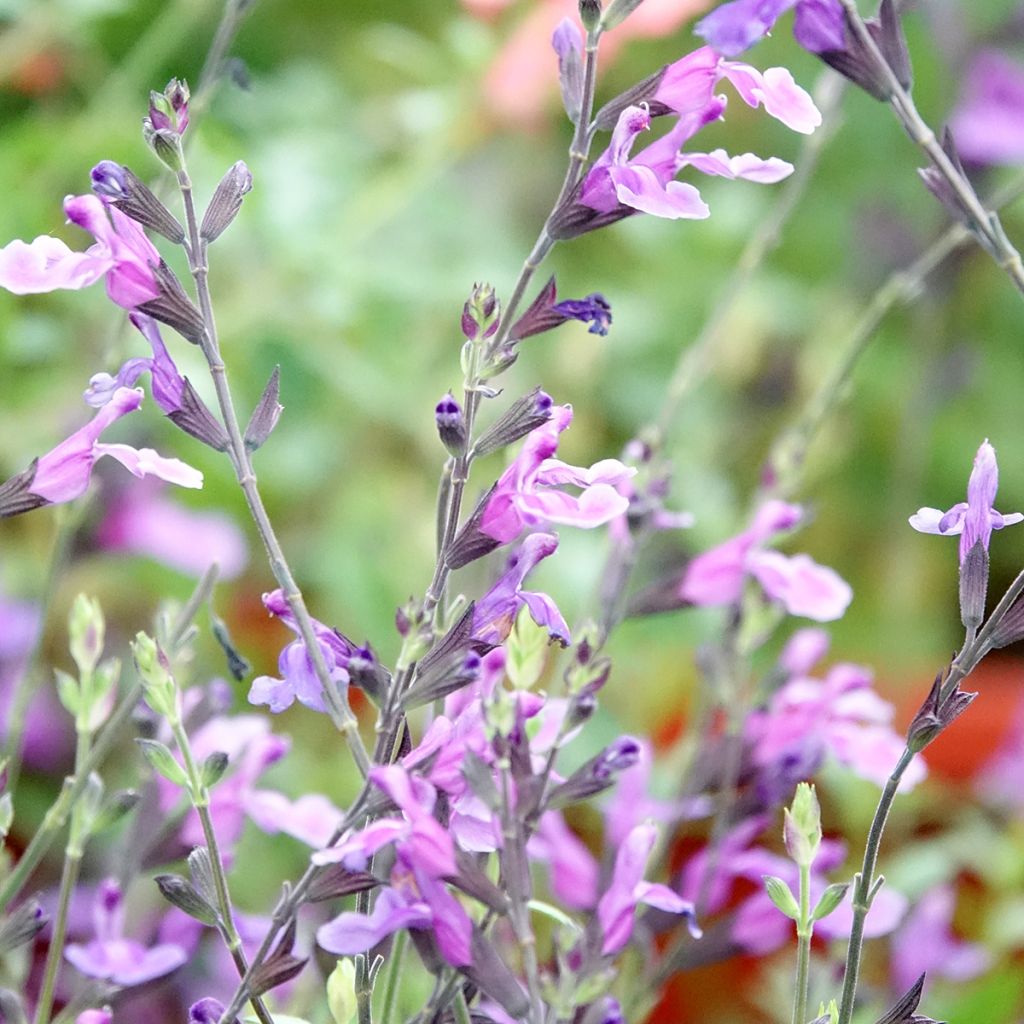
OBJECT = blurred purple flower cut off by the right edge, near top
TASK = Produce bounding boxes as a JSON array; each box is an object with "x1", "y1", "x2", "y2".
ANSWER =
[{"x1": 949, "y1": 50, "x2": 1024, "y2": 164}]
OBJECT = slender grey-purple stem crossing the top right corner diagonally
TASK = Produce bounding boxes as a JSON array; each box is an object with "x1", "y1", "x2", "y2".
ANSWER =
[{"x1": 842, "y1": 0, "x2": 1024, "y2": 292}]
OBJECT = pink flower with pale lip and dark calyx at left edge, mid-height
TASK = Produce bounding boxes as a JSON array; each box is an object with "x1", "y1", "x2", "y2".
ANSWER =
[{"x1": 0, "y1": 388, "x2": 203, "y2": 517}]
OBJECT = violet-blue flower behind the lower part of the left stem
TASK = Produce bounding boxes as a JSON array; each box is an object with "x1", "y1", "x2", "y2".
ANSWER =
[{"x1": 249, "y1": 589, "x2": 356, "y2": 714}]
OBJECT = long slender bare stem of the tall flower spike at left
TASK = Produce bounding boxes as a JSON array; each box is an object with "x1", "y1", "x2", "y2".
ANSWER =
[{"x1": 177, "y1": 159, "x2": 370, "y2": 777}]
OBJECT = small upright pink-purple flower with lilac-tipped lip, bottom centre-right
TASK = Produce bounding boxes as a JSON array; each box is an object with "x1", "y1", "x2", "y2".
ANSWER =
[{"x1": 597, "y1": 824, "x2": 700, "y2": 956}]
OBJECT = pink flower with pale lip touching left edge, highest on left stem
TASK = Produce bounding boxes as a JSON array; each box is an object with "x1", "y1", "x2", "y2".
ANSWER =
[{"x1": 0, "y1": 196, "x2": 160, "y2": 309}]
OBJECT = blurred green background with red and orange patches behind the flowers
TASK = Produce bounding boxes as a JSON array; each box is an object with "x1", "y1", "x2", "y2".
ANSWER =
[{"x1": 0, "y1": 0, "x2": 1024, "y2": 1024}]
